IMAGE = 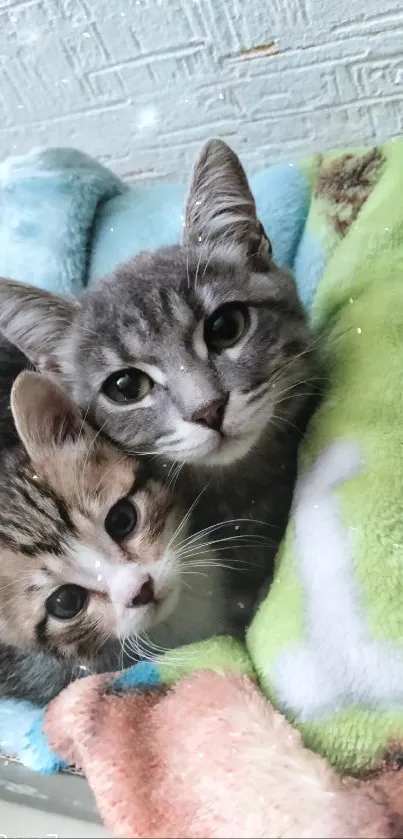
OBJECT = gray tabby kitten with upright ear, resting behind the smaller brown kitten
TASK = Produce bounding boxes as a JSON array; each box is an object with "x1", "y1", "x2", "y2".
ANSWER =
[{"x1": 0, "y1": 140, "x2": 314, "y2": 625}]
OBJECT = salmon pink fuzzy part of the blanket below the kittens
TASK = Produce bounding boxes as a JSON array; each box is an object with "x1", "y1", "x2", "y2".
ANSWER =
[{"x1": 46, "y1": 671, "x2": 403, "y2": 839}]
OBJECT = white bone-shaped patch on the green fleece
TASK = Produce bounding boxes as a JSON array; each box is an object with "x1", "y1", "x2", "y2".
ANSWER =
[{"x1": 270, "y1": 440, "x2": 403, "y2": 722}]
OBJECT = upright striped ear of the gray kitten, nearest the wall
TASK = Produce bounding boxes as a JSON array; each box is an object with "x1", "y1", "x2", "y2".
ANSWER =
[{"x1": 183, "y1": 140, "x2": 271, "y2": 265}]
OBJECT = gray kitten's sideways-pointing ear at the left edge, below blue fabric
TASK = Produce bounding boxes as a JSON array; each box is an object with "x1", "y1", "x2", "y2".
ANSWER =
[{"x1": 0, "y1": 278, "x2": 80, "y2": 370}]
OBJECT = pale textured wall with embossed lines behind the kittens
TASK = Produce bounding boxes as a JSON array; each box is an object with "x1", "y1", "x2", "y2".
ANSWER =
[{"x1": 0, "y1": 0, "x2": 403, "y2": 180}]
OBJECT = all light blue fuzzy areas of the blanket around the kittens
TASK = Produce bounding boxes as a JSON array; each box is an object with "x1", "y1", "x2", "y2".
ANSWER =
[{"x1": 0, "y1": 141, "x2": 314, "y2": 772}]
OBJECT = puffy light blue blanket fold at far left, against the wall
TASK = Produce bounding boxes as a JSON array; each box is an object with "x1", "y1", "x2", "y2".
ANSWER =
[{"x1": 0, "y1": 149, "x2": 127, "y2": 294}]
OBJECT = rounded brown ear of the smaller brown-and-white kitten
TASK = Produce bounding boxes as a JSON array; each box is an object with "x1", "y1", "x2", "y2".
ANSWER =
[{"x1": 10, "y1": 370, "x2": 83, "y2": 461}]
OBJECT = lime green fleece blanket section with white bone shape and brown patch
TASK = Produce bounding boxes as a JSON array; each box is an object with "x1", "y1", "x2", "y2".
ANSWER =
[{"x1": 248, "y1": 142, "x2": 403, "y2": 770}]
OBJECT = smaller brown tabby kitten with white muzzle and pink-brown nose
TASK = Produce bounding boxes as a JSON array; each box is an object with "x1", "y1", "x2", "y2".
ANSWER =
[{"x1": 0, "y1": 341, "x2": 225, "y2": 704}]
